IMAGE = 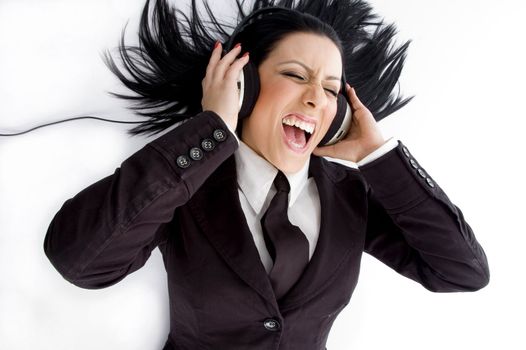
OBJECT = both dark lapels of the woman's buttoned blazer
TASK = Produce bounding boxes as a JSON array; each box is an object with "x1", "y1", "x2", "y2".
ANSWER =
[{"x1": 188, "y1": 156, "x2": 365, "y2": 311}]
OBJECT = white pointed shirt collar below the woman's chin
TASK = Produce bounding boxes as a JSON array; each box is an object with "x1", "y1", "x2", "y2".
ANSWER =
[{"x1": 234, "y1": 141, "x2": 310, "y2": 213}]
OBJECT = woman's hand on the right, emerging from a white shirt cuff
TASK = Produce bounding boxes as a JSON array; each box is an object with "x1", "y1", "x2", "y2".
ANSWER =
[{"x1": 313, "y1": 84, "x2": 385, "y2": 163}]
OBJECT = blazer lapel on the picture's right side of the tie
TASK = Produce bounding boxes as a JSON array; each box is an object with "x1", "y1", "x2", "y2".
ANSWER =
[{"x1": 279, "y1": 156, "x2": 365, "y2": 310}]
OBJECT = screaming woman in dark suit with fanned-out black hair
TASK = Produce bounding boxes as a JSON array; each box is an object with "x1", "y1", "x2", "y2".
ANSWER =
[{"x1": 45, "y1": 1, "x2": 489, "y2": 349}]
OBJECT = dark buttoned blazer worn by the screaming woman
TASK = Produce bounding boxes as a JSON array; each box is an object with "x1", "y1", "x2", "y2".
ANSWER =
[{"x1": 44, "y1": 112, "x2": 489, "y2": 350}]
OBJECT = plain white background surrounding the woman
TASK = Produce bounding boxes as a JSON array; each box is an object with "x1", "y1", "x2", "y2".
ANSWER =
[{"x1": 0, "y1": 0, "x2": 526, "y2": 350}]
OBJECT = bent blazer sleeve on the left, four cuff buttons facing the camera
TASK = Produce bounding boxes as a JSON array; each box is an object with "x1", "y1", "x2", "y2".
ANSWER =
[{"x1": 44, "y1": 111, "x2": 238, "y2": 288}]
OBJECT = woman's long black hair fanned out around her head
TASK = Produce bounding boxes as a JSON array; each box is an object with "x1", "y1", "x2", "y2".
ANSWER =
[{"x1": 105, "y1": 0, "x2": 410, "y2": 135}]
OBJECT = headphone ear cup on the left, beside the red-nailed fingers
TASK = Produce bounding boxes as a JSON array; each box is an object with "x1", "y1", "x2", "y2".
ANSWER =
[{"x1": 238, "y1": 61, "x2": 259, "y2": 120}]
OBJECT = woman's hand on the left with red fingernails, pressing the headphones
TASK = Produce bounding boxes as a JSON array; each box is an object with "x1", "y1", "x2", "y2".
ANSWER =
[{"x1": 201, "y1": 42, "x2": 249, "y2": 131}]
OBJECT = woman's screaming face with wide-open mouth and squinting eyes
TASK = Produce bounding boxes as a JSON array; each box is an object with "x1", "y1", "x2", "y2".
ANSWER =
[{"x1": 242, "y1": 33, "x2": 342, "y2": 173}]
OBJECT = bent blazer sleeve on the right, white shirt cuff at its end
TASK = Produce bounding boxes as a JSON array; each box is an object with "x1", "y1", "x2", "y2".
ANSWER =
[{"x1": 360, "y1": 142, "x2": 489, "y2": 292}]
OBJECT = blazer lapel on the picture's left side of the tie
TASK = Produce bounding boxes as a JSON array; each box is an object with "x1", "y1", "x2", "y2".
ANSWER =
[{"x1": 188, "y1": 156, "x2": 277, "y2": 308}]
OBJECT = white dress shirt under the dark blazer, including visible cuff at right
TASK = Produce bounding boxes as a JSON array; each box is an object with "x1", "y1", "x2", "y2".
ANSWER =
[{"x1": 234, "y1": 138, "x2": 398, "y2": 273}]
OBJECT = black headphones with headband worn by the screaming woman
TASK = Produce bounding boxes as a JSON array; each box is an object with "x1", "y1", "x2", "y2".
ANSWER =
[{"x1": 223, "y1": 7, "x2": 352, "y2": 146}]
